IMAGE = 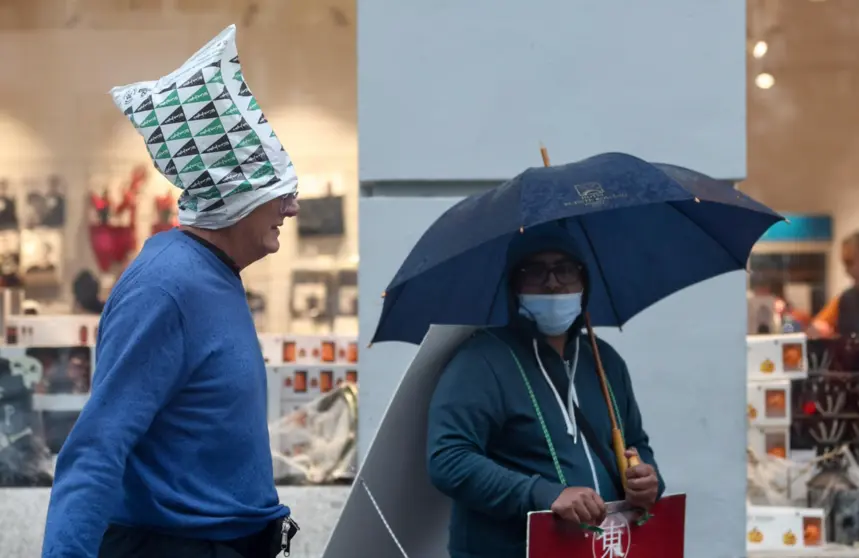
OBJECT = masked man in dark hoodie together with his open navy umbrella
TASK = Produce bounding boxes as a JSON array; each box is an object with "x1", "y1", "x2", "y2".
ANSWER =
[{"x1": 372, "y1": 151, "x2": 785, "y2": 558}]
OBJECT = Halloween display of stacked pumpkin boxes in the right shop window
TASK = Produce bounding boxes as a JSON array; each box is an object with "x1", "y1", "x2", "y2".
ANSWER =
[{"x1": 747, "y1": 334, "x2": 859, "y2": 555}]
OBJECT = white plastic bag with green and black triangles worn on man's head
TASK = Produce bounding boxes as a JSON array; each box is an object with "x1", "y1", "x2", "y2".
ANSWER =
[{"x1": 110, "y1": 25, "x2": 298, "y2": 229}]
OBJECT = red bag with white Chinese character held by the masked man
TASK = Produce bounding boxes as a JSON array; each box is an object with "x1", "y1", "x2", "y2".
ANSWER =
[{"x1": 527, "y1": 494, "x2": 686, "y2": 558}]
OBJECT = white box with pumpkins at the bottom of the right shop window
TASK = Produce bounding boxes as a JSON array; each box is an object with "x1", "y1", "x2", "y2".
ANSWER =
[{"x1": 746, "y1": 506, "x2": 826, "y2": 555}]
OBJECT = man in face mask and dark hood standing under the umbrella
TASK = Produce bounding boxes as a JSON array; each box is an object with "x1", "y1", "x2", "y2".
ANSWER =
[{"x1": 427, "y1": 225, "x2": 665, "y2": 558}]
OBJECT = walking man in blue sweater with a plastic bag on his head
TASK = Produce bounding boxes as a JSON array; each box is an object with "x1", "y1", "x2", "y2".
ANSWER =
[{"x1": 42, "y1": 26, "x2": 298, "y2": 558}]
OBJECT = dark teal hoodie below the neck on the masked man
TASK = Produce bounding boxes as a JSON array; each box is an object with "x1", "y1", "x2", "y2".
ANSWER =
[{"x1": 427, "y1": 320, "x2": 665, "y2": 558}]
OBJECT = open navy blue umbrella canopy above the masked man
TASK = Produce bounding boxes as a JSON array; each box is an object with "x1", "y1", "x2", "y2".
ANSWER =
[{"x1": 373, "y1": 153, "x2": 784, "y2": 344}]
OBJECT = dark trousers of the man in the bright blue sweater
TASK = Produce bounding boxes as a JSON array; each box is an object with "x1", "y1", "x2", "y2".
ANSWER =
[{"x1": 98, "y1": 521, "x2": 282, "y2": 558}]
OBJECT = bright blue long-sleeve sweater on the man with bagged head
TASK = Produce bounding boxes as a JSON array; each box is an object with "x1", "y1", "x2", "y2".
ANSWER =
[{"x1": 42, "y1": 230, "x2": 289, "y2": 558}]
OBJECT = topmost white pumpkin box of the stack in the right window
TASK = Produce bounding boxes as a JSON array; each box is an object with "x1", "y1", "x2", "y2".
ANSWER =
[{"x1": 746, "y1": 333, "x2": 808, "y2": 380}]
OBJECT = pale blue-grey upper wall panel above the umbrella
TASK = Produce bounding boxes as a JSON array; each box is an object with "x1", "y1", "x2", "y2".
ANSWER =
[{"x1": 358, "y1": 0, "x2": 746, "y2": 181}]
